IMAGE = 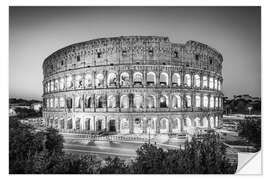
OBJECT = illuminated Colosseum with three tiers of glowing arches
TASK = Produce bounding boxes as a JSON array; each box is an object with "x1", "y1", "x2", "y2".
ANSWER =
[{"x1": 43, "y1": 36, "x2": 223, "y2": 135}]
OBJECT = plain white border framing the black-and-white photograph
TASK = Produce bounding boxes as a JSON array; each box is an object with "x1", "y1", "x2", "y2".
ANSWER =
[{"x1": 0, "y1": 0, "x2": 270, "y2": 179}]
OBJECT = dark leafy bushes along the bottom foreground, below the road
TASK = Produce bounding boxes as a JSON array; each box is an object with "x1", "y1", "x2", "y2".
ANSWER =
[{"x1": 9, "y1": 120, "x2": 236, "y2": 174}]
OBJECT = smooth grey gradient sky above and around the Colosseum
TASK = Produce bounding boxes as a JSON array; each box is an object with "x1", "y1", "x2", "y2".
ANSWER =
[{"x1": 9, "y1": 7, "x2": 261, "y2": 99}]
